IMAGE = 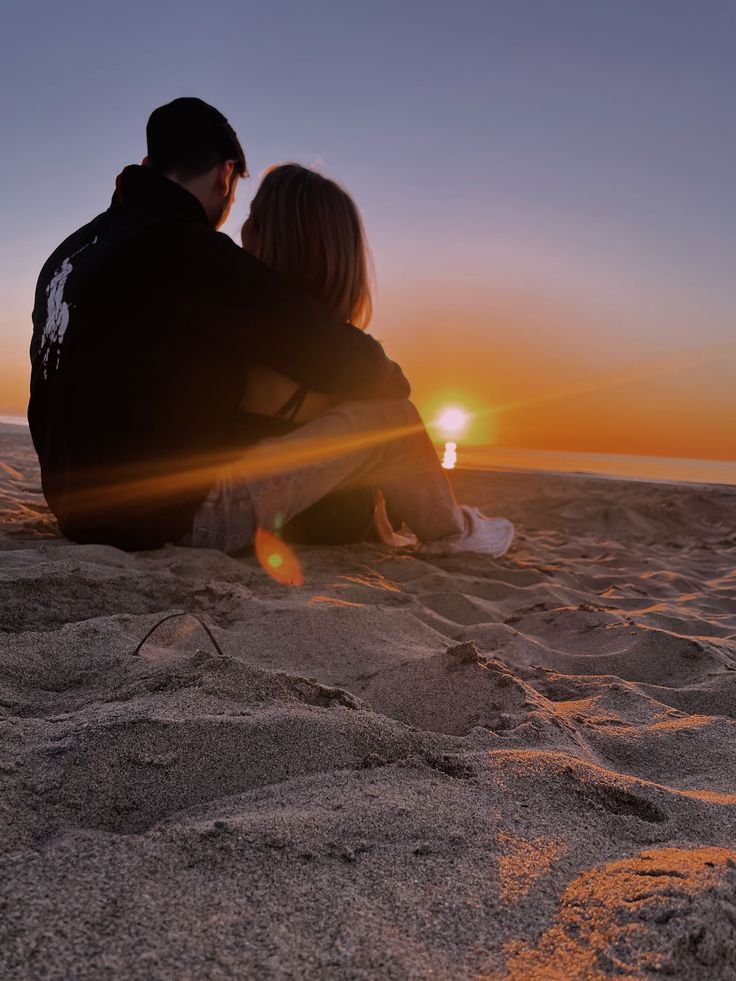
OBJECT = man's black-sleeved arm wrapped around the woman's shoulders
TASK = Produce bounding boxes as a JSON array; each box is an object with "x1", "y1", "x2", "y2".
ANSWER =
[{"x1": 177, "y1": 233, "x2": 410, "y2": 399}]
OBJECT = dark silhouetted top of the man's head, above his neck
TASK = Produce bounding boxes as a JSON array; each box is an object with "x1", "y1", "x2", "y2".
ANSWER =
[{"x1": 146, "y1": 99, "x2": 248, "y2": 180}]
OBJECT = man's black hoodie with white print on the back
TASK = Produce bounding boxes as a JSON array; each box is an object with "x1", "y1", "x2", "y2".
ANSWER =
[{"x1": 28, "y1": 167, "x2": 409, "y2": 549}]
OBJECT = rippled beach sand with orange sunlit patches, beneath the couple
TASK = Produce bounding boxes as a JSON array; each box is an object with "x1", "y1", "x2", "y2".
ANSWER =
[{"x1": 0, "y1": 427, "x2": 736, "y2": 981}]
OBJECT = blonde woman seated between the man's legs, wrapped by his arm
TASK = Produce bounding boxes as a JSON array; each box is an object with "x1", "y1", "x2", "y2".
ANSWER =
[{"x1": 240, "y1": 163, "x2": 402, "y2": 545}]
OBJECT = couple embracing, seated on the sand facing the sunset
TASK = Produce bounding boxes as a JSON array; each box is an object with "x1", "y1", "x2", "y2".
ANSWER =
[{"x1": 28, "y1": 99, "x2": 513, "y2": 556}]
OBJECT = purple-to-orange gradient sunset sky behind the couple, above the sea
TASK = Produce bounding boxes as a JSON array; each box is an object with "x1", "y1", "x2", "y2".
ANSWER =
[{"x1": 0, "y1": 0, "x2": 736, "y2": 459}]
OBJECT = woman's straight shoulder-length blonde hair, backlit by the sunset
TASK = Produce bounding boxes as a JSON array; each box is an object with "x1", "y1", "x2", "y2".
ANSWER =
[{"x1": 243, "y1": 163, "x2": 373, "y2": 328}]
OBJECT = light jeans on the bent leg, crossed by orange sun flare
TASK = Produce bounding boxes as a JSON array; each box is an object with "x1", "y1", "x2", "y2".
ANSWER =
[{"x1": 188, "y1": 399, "x2": 464, "y2": 553}]
